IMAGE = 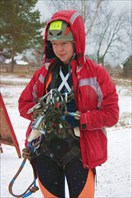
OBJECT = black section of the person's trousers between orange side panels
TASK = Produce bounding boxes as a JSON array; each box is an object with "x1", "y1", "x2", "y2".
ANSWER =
[{"x1": 33, "y1": 138, "x2": 94, "y2": 198}]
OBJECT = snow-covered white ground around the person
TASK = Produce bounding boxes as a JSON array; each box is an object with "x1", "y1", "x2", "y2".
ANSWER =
[{"x1": 0, "y1": 75, "x2": 132, "y2": 198}]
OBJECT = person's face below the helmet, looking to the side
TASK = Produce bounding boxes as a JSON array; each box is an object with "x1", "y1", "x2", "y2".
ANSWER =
[{"x1": 52, "y1": 41, "x2": 74, "y2": 64}]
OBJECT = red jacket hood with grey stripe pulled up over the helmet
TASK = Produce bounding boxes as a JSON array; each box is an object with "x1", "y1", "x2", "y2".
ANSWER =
[{"x1": 44, "y1": 10, "x2": 85, "y2": 66}]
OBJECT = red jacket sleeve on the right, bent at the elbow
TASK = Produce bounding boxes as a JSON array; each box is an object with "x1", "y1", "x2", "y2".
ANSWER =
[{"x1": 80, "y1": 67, "x2": 119, "y2": 130}]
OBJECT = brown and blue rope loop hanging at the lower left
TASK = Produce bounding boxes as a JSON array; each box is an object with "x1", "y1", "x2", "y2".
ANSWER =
[{"x1": 8, "y1": 159, "x2": 39, "y2": 198}]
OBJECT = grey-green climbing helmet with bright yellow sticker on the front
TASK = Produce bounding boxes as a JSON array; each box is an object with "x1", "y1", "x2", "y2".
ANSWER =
[{"x1": 47, "y1": 20, "x2": 74, "y2": 41}]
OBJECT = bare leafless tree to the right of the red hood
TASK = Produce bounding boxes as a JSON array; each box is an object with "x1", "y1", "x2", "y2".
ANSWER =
[{"x1": 94, "y1": 5, "x2": 131, "y2": 65}]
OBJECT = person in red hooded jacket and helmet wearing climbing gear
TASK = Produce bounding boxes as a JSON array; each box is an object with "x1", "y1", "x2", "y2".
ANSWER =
[{"x1": 19, "y1": 10, "x2": 119, "y2": 198}]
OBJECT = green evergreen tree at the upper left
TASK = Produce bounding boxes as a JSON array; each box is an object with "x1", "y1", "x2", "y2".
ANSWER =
[{"x1": 0, "y1": 0, "x2": 44, "y2": 72}]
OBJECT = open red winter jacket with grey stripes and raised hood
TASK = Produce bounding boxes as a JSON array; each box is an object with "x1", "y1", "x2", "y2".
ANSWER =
[{"x1": 19, "y1": 10, "x2": 119, "y2": 168}]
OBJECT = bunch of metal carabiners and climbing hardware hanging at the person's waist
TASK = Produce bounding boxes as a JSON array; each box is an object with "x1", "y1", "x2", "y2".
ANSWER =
[{"x1": 27, "y1": 89, "x2": 77, "y2": 142}]
